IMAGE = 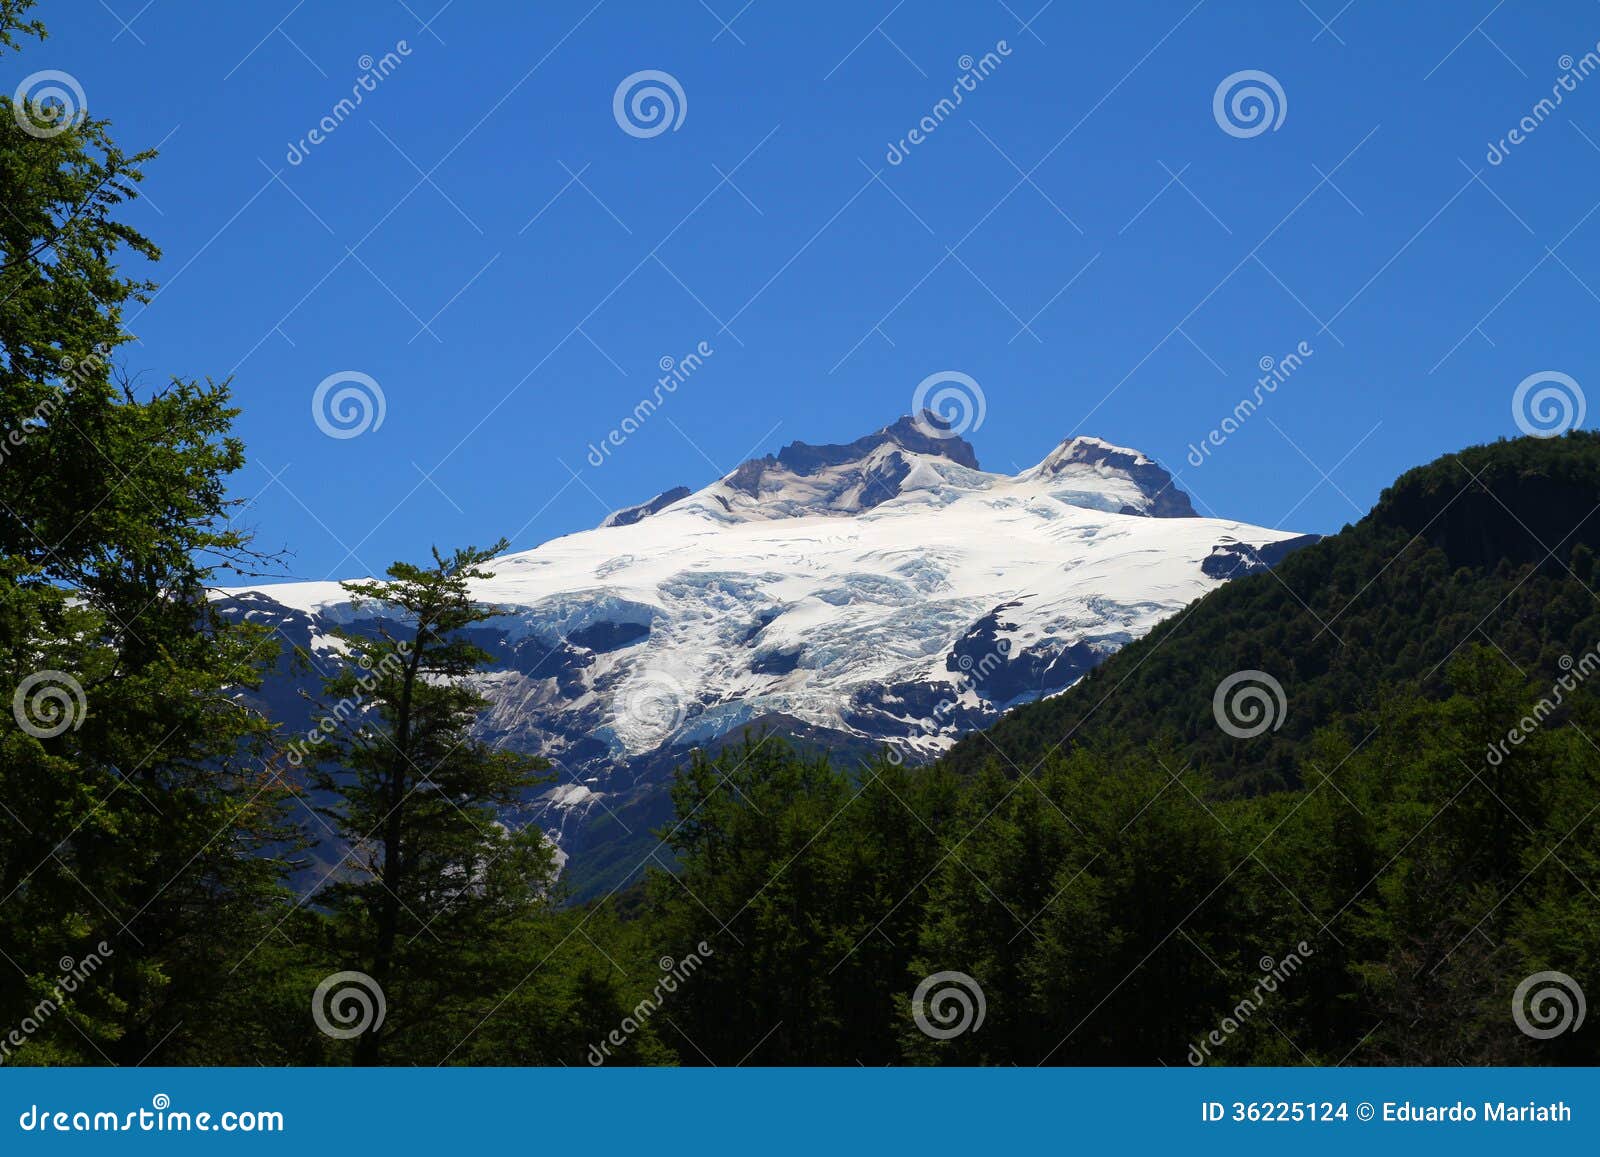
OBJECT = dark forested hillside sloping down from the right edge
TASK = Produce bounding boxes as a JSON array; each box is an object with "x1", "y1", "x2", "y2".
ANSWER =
[{"x1": 946, "y1": 432, "x2": 1600, "y2": 792}]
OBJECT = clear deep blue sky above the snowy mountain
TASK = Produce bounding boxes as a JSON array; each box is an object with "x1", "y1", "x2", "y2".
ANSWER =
[{"x1": 25, "y1": 0, "x2": 1600, "y2": 578}]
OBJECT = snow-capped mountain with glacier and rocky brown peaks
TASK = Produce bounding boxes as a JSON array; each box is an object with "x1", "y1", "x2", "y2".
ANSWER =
[{"x1": 221, "y1": 413, "x2": 1314, "y2": 896}]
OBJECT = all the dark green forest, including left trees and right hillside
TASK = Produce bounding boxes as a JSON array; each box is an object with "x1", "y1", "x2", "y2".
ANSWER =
[{"x1": 0, "y1": 0, "x2": 1600, "y2": 1066}]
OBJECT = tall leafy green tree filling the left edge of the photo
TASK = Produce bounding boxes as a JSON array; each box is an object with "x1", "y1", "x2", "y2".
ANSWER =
[{"x1": 0, "y1": 3, "x2": 293, "y2": 1063}]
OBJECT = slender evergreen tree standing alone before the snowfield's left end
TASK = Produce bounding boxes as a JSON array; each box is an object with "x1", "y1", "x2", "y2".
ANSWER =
[{"x1": 314, "y1": 539, "x2": 555, "y2": 1064}]
